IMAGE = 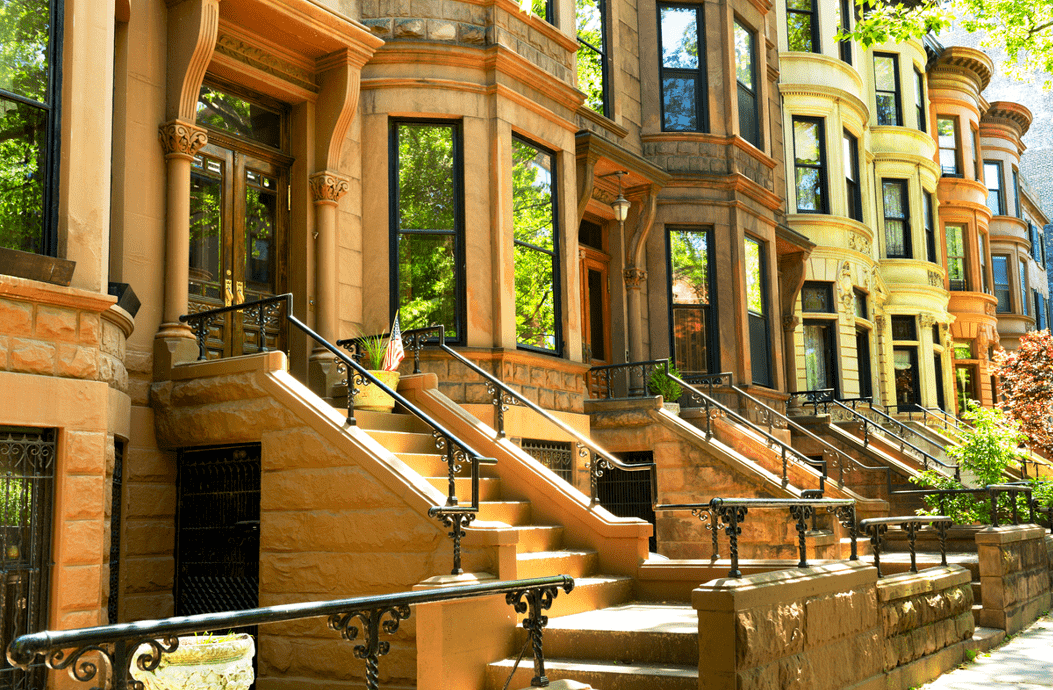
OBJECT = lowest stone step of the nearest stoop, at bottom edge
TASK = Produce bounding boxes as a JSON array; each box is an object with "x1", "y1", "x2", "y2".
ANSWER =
[{"x1": 486, "y1": 650, "x2": 698, "y2": 690}]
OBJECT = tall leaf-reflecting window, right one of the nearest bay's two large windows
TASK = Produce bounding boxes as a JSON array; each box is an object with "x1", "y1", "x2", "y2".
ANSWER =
[{"x1": 512, "y1": 138, "x2": 562, "y2": 354}]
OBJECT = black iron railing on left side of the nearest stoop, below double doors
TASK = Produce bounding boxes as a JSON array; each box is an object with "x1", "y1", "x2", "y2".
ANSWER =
[{"x1": 179, "y1": 294, "x2": 497, "y2": 575}]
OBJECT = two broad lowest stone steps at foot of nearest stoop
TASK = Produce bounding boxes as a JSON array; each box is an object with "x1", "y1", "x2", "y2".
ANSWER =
[{"x1": 486, "y1": 604, "x2": 698, "y2": 690}]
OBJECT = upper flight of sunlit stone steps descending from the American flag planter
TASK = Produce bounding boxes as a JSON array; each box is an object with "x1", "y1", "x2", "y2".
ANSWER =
[{"x1": 355, "y1": 410, "x2": 633, "y2": 619}]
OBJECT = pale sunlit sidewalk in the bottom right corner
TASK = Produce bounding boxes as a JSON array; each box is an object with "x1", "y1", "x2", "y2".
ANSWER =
[{"x1": 921, "y1": 614, "x2": 1053, "y2": 690}]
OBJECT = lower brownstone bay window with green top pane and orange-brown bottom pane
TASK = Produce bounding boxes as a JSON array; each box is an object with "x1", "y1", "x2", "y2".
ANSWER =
[{"x1": 669, "y1": 228, "x2": 719, "y2": 374}]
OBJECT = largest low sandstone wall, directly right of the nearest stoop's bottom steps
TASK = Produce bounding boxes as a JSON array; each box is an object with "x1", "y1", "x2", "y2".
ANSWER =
[{"x1": 692, "y1": 563, "x2": 883, "y2": 690}]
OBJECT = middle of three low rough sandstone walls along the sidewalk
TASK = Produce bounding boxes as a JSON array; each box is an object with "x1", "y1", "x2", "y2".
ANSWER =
[{"x1": 877, "y1": 566, "x2": 976, "y2": 689}]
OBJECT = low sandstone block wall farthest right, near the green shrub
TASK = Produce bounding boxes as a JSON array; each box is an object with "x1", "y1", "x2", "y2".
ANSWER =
[{"x1": 976, "y1": 525, "x2": 1050, "y2": 634}]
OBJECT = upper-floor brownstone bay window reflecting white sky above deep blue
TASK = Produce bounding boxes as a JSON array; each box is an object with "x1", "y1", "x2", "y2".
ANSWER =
[{"x1": 658, "y1": 4, "x2": 709, "y2": 132}]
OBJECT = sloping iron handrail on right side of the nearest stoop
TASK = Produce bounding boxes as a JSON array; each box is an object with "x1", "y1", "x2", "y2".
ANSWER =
[{"x1": 425, "y1": 326, "x2": 658, "y2": 505}]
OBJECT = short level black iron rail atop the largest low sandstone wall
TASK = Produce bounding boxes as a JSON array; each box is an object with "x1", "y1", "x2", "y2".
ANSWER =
[{"x1": 655, "y1": 492, "x2": 859, "y2": 577}]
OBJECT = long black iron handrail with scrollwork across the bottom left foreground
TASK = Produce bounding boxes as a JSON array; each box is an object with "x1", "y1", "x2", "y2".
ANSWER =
[{"x1": 7, "y1": 575, "x2": 574, "y2": 690}]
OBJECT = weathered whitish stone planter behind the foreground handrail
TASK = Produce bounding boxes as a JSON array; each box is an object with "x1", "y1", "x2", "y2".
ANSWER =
[{"x1": 132, "y1": 633, "x2": 256, "y2": 690}]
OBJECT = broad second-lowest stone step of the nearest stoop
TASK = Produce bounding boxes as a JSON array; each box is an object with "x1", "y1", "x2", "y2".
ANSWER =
[{"x1": 534, "y1": 603, "x2": 698, "y2": 668}]
